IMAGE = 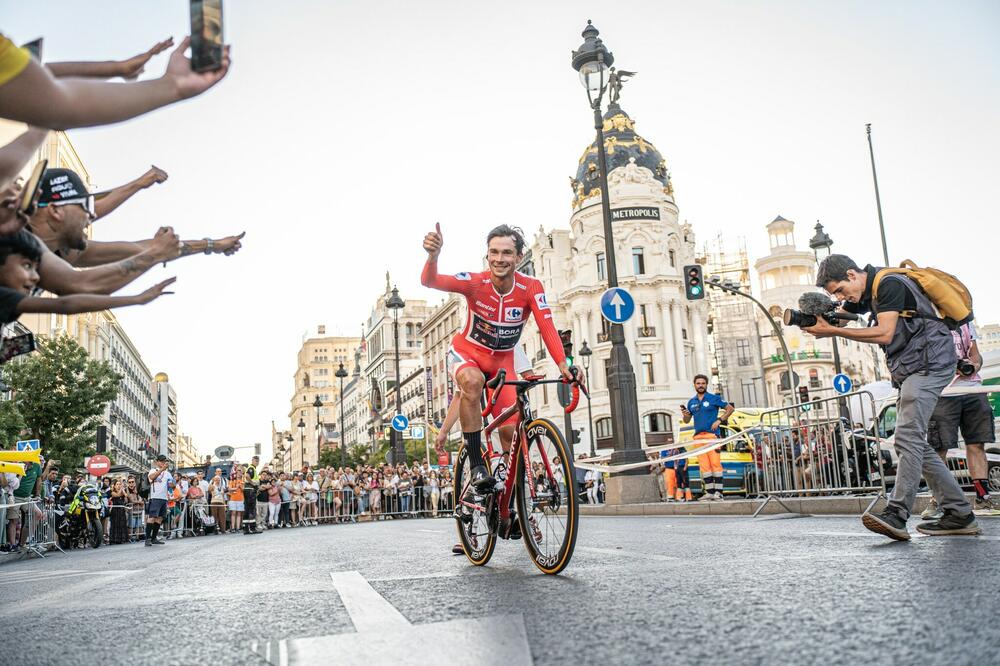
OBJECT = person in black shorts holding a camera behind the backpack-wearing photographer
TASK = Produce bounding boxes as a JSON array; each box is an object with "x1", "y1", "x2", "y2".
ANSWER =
[{"x1": 920, "y1": 324, "x2": 1000, "y2": 518}]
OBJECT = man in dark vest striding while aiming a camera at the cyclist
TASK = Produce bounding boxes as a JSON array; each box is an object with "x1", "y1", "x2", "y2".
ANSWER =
[{"x1": 803, "y1": 254, "x2": 981, "y2": 541}]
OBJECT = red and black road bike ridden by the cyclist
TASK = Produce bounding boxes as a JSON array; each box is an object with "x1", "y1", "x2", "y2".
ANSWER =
[{"x1": 455, "y1": 368, "x2": 586, "y2": 575}]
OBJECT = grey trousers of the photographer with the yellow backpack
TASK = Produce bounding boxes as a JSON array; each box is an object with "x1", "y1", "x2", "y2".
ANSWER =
[{"x1": 889, "y1": 368, "x2": 972, "y2": 518}]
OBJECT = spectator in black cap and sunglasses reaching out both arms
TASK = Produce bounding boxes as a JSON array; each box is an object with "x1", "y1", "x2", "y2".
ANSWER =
[{"x1": 30, "y1": 167, "x2": 243, "y2": 272}]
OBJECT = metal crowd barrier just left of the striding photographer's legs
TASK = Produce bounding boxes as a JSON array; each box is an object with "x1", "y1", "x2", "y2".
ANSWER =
[{"x1": 753, "y1": 391, "x2": 885, "y2": 516}]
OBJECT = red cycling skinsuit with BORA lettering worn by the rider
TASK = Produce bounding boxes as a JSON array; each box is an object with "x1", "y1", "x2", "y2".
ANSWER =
[{"x1": 420, "y1": 261, "x2": 566, "y2": 408}]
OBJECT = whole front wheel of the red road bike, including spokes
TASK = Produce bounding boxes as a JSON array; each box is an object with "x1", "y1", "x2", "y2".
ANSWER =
[{"x1": 515, "y1": 419, "x2": 580, "y2": 575}]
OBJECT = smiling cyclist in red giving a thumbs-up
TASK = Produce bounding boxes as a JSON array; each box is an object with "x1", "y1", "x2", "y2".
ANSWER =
[{"x1": 421, "y1": 224, "x2": 578, "y2": 490}]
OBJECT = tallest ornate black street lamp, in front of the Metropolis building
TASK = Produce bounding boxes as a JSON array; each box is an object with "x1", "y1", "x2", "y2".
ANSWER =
[{"x1": 572, "y1": 21, "x2": 646, "y2": 466}]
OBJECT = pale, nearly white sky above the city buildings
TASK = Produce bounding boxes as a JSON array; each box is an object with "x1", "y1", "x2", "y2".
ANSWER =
[{"x1": 0, "y1": 0, "x2": 1000, "y2": 451}]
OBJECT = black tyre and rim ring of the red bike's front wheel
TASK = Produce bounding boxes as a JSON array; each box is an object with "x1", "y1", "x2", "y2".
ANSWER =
[{"x1": 515, "y1": 418, "x2": 580, "y2": 576}]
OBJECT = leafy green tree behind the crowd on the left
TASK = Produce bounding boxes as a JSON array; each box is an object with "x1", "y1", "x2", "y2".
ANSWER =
[{"x1": 0, "y1": 335, "x2": 122, "y2": 469}]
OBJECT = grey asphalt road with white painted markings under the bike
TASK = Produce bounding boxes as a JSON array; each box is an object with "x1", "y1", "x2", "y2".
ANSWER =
[{"x1": 0, "y1": 516, "x2": 1000, "y2": 666}]
